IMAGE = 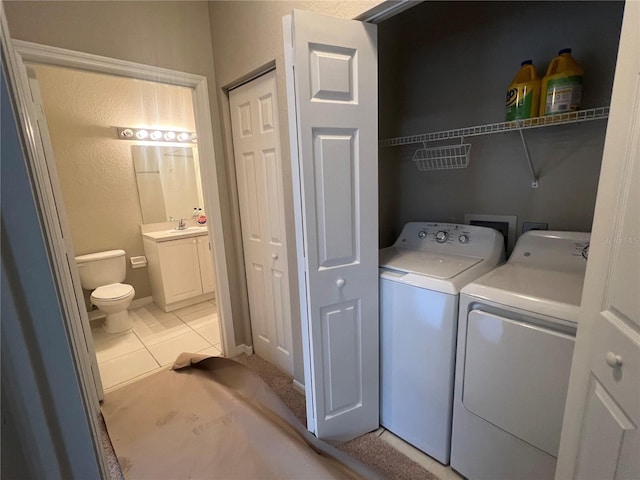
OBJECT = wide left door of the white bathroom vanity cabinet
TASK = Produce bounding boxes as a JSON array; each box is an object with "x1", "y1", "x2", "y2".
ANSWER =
[{"x1": 158, "y1": 238, "x2": 202, "y2": 303}]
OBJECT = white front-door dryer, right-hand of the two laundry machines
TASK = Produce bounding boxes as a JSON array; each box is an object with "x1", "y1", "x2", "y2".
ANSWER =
[{"x1": 451, "y1": 231, "x2": 589, "y2": 480}]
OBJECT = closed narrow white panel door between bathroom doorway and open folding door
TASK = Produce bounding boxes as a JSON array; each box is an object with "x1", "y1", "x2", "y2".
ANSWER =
[{"x1": 229, "y1": 71, "x2": 293, "y2": 375}]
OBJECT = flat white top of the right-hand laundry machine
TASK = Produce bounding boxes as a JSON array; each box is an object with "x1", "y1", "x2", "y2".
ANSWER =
[{"x1": 461, "y1": 263, "x2": 584, "y2": 322}]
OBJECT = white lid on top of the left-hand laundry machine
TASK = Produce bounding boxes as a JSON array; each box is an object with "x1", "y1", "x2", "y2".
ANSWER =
[{"x1": 380, "y1": 247, "x2": 482, "y2": 279}]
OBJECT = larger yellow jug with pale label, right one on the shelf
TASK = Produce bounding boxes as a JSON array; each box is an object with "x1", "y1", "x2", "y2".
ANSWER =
[{"x1": 540, "y1": 48, "x2": 584, "y2": 116}]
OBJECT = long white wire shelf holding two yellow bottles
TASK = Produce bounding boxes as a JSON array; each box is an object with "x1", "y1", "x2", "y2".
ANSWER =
[{"x1": 379, "y1": 107, "x2": 609, "y2": 147}]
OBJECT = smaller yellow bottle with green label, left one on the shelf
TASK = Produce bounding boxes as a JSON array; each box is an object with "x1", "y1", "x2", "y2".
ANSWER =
[{"x1": 506, "y1": 60, "x2": 540, "y2": 122}]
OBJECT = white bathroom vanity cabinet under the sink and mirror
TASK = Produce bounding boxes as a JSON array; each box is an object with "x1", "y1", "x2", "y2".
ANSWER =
[{"x1": 143, "y1": 229, "x2": 215, "y2": 312}]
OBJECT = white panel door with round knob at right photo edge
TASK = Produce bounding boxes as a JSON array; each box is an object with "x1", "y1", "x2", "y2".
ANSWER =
[{"x1": 556, "y1": 1, "x2": 640, "y2": 479}]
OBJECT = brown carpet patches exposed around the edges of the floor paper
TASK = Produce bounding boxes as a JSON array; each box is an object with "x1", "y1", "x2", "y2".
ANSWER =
[{"x1": 102, "y1": 354, "x2": 438, "y2": 480}]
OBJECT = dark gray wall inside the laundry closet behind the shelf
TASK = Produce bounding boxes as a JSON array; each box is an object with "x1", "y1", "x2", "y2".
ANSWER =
[{"x1": 379, "y1": 2, "x2": 623, "y2": 247}]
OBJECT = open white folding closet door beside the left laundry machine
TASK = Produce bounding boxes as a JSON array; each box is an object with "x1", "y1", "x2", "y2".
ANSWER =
[{"x1": 284, "y1": 10, "x2": 379, "y2": 441}]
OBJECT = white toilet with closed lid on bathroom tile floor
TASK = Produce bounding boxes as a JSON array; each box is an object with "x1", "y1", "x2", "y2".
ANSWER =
[{"x1": 76, "y1": 250, "x2": 136, "y2": 333}]
